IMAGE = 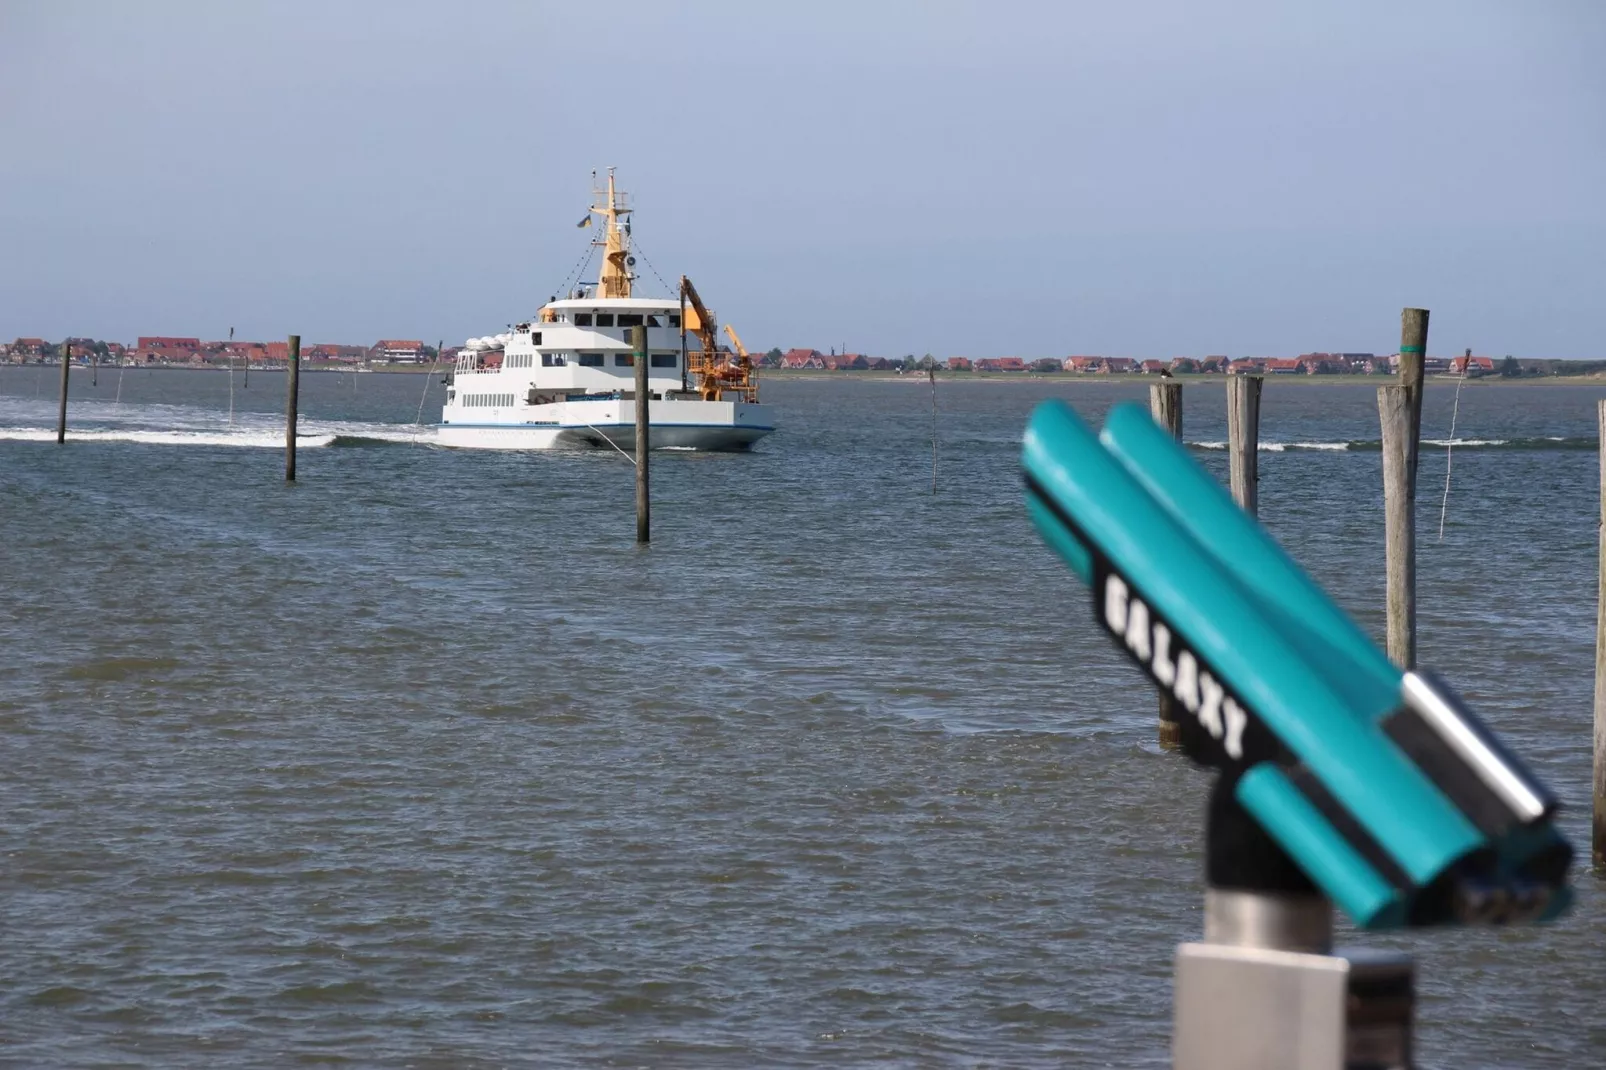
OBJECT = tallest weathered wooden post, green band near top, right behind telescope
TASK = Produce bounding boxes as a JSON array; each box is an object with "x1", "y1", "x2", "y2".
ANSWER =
[{"x1": 1378, "y1": 308, "x2": 1428, "y2": 668}]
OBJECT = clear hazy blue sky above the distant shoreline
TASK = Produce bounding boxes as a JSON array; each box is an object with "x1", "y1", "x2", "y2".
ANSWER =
[{"x1": 0, "y1": 0, "x2": 1606, "y2": 358}]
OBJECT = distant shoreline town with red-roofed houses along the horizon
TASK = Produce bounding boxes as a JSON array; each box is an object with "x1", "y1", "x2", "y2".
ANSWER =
[{"x1": 0, "y1": 334, "x2": 1606, "y2": 379}]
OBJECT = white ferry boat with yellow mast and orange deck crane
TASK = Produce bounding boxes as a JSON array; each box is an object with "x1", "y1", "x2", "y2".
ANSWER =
[{"x1": 437, "y1": 167, "x2": 776, "y2": 451}]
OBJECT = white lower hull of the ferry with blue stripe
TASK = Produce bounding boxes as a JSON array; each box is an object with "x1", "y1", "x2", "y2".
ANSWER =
[{"x1": 435, "y1": 398, "x2": 774, "y2": 453}]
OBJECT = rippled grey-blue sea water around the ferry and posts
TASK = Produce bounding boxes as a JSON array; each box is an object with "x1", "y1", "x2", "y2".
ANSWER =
[{"x1": 0, "y1": 368, "x2": 1606, "y2": 1068}]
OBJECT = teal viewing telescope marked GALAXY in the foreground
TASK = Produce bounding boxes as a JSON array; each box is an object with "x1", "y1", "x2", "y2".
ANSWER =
[{"x1": 1023, "y1": 402, "x2": 1572, "y2": 1067}]
